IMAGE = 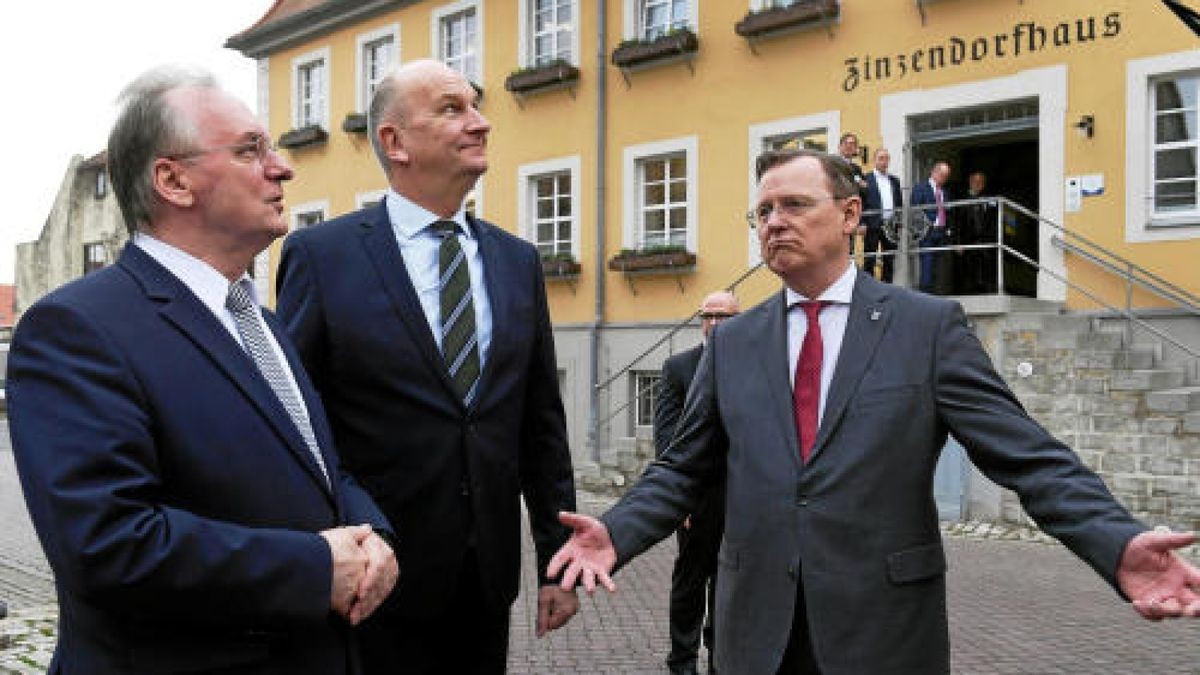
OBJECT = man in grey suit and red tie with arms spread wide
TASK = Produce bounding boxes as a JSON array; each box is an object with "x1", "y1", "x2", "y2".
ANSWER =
[{"x1": 548, "y1": 150, "x2": 1200, "y2": 675}]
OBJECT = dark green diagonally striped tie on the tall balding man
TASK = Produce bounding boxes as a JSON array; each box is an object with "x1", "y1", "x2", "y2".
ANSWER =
[{"x1": 431, "y1": 220, "x2": 479, "y2": 406}]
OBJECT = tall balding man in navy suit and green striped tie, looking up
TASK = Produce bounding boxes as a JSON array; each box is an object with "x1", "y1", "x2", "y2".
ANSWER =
[{"x1": 278, "y1": 60, "x2": 578, "y2": 675}]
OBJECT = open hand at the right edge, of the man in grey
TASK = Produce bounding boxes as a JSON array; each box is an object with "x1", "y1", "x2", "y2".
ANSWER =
[{"x1": 1117, "y1": 531, "x2": 1200, "y2": 621}]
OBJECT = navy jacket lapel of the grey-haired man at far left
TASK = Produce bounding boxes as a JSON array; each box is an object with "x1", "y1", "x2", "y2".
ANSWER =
[{"x1": 120, "y1": 244, "x2": 332, "y2": 495}]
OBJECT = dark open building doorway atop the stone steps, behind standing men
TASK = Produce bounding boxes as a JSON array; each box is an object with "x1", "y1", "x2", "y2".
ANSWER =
[{"x1": 908, "y1": 98, "x2": 1040, "y2": 297}]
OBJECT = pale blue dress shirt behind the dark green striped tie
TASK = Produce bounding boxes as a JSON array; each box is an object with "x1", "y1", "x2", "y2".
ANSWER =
[{"x1": 384, "y1": 189, "x2": 492, "y2": 369}]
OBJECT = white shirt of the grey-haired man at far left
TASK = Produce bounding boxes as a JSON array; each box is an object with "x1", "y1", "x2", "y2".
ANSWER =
[{"x1": 133, "y1": 232, "x2": 308, "y2": 417}]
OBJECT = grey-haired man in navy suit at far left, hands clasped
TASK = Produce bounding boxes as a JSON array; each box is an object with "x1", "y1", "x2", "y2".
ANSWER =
[{"x1": 8, "y1": 68, "x2": 397, "y2": 675}]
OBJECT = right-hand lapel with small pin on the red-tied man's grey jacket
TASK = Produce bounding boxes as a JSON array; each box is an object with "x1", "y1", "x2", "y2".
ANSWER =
[{"x1": 809, "y1": 271, "x2": 892, "y2": 462}]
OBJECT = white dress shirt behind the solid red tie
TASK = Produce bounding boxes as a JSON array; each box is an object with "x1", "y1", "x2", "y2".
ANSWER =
[{"x1": 785, "y1": 262, "x2": 858, "y2": 425}]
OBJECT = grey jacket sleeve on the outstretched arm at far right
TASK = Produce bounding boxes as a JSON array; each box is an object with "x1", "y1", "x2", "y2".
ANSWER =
[{"x1": 935, "y1": 303, "x2": 1146, "y2": 586}]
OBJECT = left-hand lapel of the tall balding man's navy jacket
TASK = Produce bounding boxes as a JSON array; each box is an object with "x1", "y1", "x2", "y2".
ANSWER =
[{"x1": 362, "y1": 204, "x2": 461, "y2": 402}]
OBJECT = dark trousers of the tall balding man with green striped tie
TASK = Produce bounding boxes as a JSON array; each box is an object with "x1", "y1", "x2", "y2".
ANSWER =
[{"x1": 359, "y1": 550, "x2": 509, "y2": 675}]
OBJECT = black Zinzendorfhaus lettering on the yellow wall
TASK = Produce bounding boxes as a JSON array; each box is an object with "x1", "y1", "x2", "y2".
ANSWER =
[{"x1": 841, "y1": 12, "x2": 1121, "y2": 92}]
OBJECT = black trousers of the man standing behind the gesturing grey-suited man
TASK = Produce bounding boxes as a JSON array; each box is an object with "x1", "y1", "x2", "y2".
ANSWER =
[{"x1": 667, "y1": 490, "x2": 725, "y2": 670}]
